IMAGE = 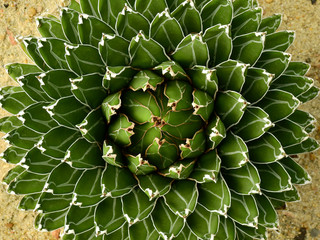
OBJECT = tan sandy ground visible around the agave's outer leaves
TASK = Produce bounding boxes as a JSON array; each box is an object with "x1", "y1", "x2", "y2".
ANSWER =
[{"x1": 0, "y1": 0, "x2": 320, "y2": 240}]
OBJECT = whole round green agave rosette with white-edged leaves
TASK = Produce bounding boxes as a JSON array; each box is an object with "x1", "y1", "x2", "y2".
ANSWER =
[{"x1": 0, "y1": 0, "x2": 318, "y2": 240}]
